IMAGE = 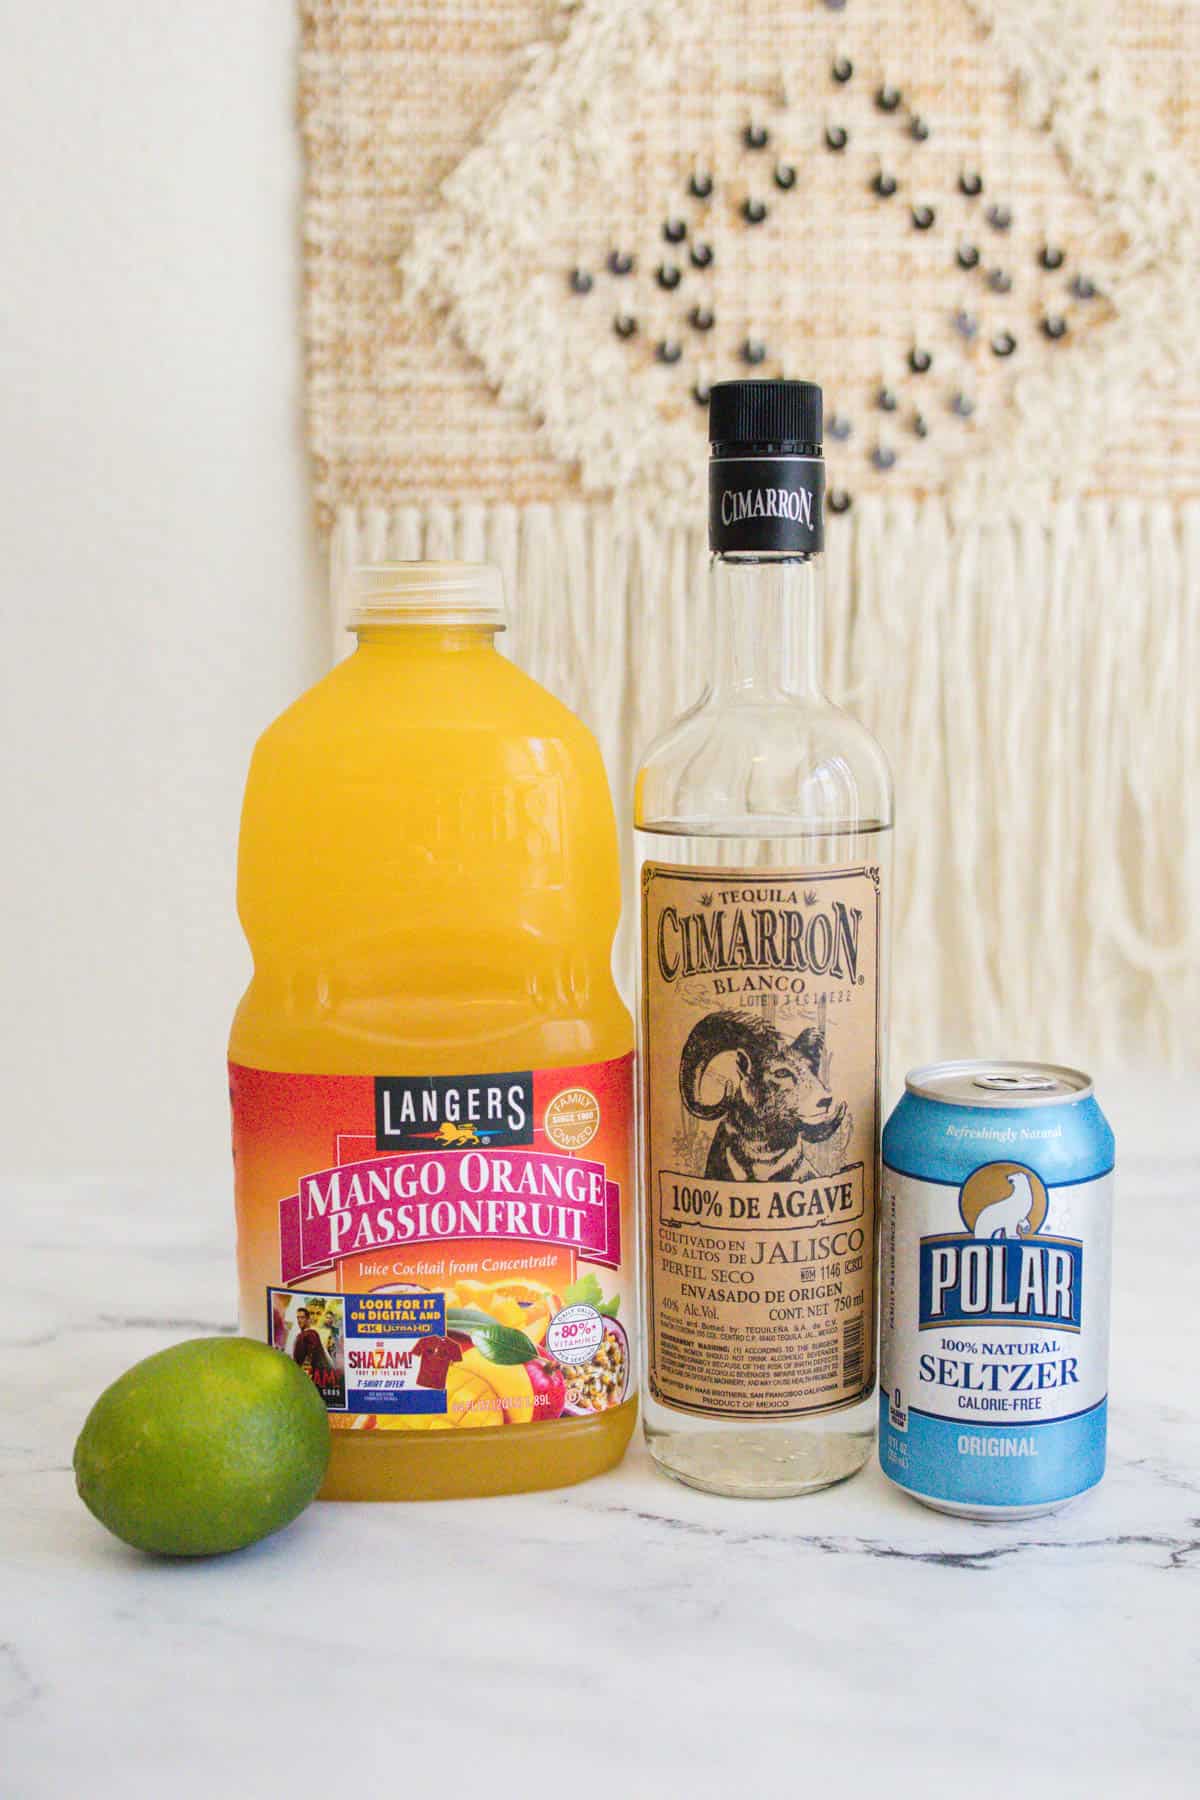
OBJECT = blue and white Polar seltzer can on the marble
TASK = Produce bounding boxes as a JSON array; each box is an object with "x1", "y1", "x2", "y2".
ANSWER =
[{"x1": 880, "y1": 1062, "x2": 1114, "y2": 1519}]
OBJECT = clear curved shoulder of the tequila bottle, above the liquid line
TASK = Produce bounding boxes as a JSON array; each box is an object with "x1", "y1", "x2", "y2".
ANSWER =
[{"x1": 635, "y1": 697, "x2": 892, "y2": 828}]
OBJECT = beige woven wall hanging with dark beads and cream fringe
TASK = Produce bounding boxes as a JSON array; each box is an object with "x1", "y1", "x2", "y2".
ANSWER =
[{"x1": 302, "y1": 0, "x2": 1200, "y2": 1064}]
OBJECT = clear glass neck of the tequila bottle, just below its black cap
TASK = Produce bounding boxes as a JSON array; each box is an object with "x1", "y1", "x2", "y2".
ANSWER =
[{"x1": 711, "y1": 554, "x2": 824, "y2": 706}]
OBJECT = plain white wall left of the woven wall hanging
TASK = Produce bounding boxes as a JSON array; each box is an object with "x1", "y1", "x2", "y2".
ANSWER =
[{"x1": 0, "y1": 0, "x2": 326, "y2": 1175}]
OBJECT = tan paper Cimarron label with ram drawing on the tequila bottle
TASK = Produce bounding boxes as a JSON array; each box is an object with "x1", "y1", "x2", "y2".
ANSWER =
[{"x1": 640, "y1": 862, "x2": 880, "y2": 1418}]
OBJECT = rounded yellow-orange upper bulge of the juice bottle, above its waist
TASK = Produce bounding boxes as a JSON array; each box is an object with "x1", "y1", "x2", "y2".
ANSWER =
[{"x1": 237, "y1": 652, "x2": 621, "y2": 979}]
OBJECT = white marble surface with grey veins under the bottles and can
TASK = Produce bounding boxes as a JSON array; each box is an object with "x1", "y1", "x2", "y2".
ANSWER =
[{"x1": 0, "y1": 1082, "x2": 1200, "y2": 1800}]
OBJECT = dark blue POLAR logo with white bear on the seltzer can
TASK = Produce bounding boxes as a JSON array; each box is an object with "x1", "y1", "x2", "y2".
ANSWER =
[{"x1": 919, "y1": 1163, "x2": 1083, "y2": 1332}]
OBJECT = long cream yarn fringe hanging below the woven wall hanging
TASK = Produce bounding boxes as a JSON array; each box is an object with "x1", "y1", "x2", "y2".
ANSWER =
[{"x1": 333, "y1": 499, "x2": 1200, "y2": 1073}]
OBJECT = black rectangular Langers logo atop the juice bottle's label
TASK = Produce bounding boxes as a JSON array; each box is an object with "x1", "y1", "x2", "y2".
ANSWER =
[{"x1": 374, "y1": 1069, "x2": 533, "y2": 1150}]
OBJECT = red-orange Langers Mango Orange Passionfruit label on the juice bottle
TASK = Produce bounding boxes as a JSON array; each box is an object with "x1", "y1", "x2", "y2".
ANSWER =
[{"x1": 230, "y1": 1057, "x2": 635, "y2": 1431}]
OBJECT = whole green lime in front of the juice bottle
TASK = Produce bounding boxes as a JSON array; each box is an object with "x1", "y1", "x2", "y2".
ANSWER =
[{"x1": 76, "y1": 1337, "x2": 329, "y2": 1557}]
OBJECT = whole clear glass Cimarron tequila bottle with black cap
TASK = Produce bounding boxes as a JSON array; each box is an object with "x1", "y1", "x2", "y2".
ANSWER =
[{"x1": 635, "y1": 382, "x2": 892, "y2": 1498}]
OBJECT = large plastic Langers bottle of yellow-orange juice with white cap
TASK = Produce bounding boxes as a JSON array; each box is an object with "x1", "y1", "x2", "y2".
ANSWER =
[{"x1": 228, "y1": 563, "x2": 637, "y2": 1499}]
